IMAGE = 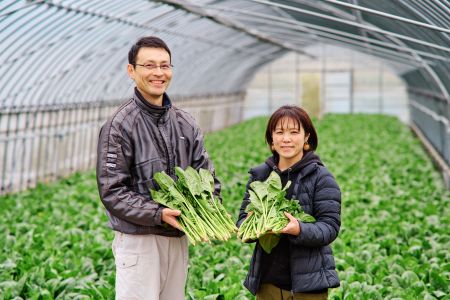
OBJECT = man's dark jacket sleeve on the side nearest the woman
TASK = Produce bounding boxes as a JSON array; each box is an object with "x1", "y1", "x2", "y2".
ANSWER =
[{"x1": 191, "y1": 124, "x2": 222, "y2": 197}]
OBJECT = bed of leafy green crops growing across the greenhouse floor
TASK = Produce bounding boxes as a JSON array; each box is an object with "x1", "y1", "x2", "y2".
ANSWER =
[{"x1": 0, "y1": 115, "x2": 450, "y2": 299}]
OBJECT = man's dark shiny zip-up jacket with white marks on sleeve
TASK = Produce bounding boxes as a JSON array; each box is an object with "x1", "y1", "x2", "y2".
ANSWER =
[{"x1": 97, "y1": 90, "x2": 220, "y2": 236}]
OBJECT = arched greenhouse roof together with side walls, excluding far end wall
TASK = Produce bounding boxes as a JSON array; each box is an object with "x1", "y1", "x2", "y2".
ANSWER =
[{"x1": 0, "y1": 0, "x2": 450, "y2": 193}]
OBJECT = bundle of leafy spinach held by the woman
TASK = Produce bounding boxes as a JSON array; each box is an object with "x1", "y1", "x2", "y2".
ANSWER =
[{"x1": 238, "y1": 171, "x2": 316, "y2": 253}]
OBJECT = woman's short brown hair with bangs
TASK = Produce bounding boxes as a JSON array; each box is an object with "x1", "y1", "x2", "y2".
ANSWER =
[{"x1": 266, "y1": 105, "x2": 319, "y2": 156}]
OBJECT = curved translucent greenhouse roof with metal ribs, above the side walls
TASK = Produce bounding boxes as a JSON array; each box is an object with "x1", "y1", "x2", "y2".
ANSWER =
[{"x1": 0, "y1": 0, "x2": 450, "y2": 108}]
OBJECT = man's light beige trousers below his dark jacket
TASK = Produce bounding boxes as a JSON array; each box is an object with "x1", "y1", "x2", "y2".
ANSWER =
[{"x1": 112, "y1": 232, "x2": 188, "y2": 300}]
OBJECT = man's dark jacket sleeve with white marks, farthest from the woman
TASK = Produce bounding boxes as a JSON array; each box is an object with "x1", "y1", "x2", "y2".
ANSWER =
[{"x1": 97, "y1": 121, "x2": 163, "y2": 226}]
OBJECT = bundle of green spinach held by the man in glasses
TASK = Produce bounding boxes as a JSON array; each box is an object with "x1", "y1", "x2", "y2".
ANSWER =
[{"x1": 150, "y1": 167, "x2": 237, "y2": 245}]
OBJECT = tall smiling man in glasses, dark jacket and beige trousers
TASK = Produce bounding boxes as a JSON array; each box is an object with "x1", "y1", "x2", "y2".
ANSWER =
[{"x1": 97, "y1": 37, "x2": 220, "y2": 300}]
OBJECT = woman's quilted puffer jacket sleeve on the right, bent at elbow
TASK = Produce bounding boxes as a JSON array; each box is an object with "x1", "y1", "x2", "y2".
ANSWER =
[{"x1": 289, "y1": 168, "x2": 341, "y2": 247}]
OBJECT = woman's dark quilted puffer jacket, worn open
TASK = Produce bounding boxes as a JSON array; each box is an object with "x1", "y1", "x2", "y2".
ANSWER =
[{"x1": 237, "y1": 152, "x2": 341, "y2": 295}]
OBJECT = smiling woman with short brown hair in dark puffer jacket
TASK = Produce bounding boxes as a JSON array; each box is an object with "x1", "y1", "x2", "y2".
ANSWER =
[{"x1": 237, "y1": 105, "x2": 341, "y2": 300}]
